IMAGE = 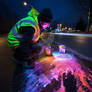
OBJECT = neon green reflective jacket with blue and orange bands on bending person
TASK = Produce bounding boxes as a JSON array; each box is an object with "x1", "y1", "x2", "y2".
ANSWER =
[{"x1": 8, "y1": 8, "x2": 40, "y2": 49}]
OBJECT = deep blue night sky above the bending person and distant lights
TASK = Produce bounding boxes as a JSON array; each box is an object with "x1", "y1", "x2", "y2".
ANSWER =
[{"x1": 0, "y1": 0, "x2": 87, "y2": 33}]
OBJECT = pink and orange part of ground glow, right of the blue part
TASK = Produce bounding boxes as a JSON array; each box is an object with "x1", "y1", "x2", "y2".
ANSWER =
[{"x1": 37, "y1": 55, "x2": 92, "y2": 92}]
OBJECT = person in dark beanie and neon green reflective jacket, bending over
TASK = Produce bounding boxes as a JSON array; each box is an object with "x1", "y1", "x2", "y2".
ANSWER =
[{"x1": 8, "y1": 8, "x2": 52, "y2": 68}]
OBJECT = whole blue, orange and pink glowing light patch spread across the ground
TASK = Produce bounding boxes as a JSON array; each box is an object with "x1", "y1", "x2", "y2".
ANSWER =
[{"x1": 20, "y1": 53, "x2": 92, "y2": 92}]
